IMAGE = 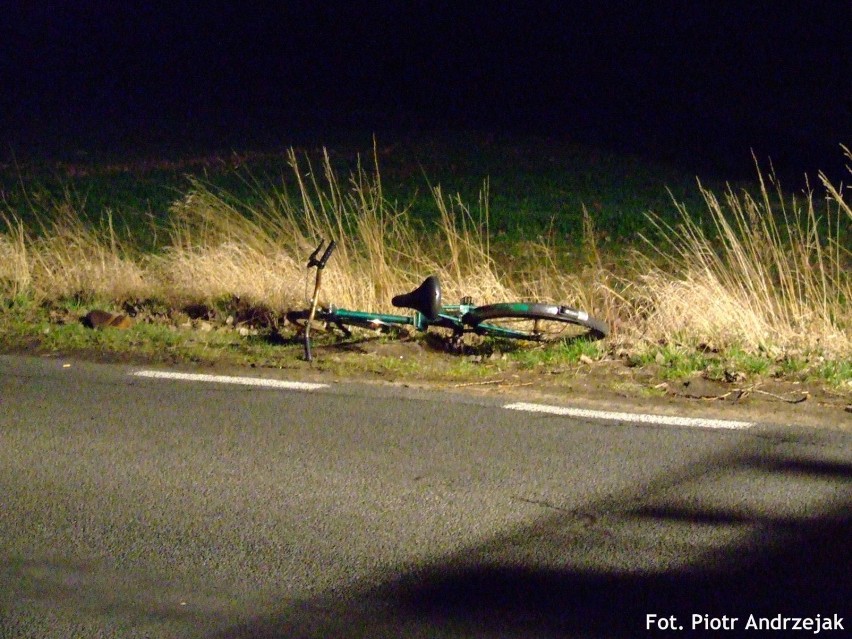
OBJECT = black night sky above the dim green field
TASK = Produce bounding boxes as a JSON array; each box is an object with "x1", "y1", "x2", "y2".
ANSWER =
[{"x1": 0, "y1": 0, "x2": 852, "y2": 177}]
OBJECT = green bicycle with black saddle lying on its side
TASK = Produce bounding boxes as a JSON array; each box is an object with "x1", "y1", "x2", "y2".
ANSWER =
[{"x1": 287, "y1": 240, "x2": 609, "y2": 361}]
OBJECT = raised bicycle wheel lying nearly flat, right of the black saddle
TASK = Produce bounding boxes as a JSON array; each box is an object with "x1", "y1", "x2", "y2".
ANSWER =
[{"x1": 462, "y1": 302, "x2": 609, "y2": 342}]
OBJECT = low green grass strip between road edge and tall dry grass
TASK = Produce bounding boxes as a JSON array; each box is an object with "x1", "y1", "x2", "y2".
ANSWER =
[{"x1": 0, "y1": 298, "x2": 852, "y2": 395}]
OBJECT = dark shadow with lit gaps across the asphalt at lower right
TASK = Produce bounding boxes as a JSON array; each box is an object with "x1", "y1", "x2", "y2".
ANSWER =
[{"x1": 219, "y1": 448, "x2": 852, "y2": 639}]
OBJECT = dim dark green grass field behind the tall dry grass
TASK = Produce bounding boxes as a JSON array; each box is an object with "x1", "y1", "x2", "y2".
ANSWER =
[{"x1": 0, "y1": 136, "x2": 721, "y2": 248}]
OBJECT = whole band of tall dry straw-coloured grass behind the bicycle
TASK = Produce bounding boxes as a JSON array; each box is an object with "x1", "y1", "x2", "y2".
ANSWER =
[{"x1": 0, "y1": 146, "x2": 852, "y2": 364}]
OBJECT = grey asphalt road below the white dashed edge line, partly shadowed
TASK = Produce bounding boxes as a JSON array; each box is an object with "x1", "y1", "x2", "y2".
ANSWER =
[{"x1": 0, "y1": 356, "x2": 852, "y2": 639}]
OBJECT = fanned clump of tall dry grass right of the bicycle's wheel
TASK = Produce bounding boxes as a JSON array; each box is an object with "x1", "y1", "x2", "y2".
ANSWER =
[{"x1": 632, "y1": 153, "x2": 852, "y2": 357}]
